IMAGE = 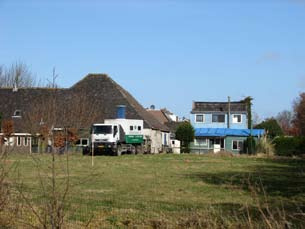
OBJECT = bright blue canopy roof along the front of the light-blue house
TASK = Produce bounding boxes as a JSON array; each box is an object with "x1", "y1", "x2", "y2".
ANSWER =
[{"x1": 195, "y1": 128, "x2": 265, "y2": 137}]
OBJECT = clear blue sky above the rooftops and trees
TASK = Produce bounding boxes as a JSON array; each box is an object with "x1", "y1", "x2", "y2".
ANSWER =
[{"x1": 0, "y1": 0, "x2": 305, "y2": 121}]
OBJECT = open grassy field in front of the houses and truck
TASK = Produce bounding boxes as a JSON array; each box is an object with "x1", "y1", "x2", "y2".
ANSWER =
[{"x1": 2, "y1": 155, "x2": 305, "y2": 228}]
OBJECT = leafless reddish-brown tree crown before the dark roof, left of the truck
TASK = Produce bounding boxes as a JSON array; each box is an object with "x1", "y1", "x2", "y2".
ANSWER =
[{"x1": 23, "y1": 68, "x2": 98, "y2": 152}]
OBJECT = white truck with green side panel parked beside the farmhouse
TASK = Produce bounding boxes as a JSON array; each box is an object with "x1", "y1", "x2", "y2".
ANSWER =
[{"x1": 83, "y1": 119, "x2": 144, "y2": 156}]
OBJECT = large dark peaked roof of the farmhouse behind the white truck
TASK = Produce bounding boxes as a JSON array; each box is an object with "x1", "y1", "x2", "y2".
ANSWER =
[{"x1": 0, "y1": 74, "x2": 169, "y2": 132}]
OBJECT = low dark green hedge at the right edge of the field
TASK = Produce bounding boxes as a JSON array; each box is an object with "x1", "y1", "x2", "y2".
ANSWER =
[{"x1": 273, "y1": 137, "x2": 305, "y2": 156}]
